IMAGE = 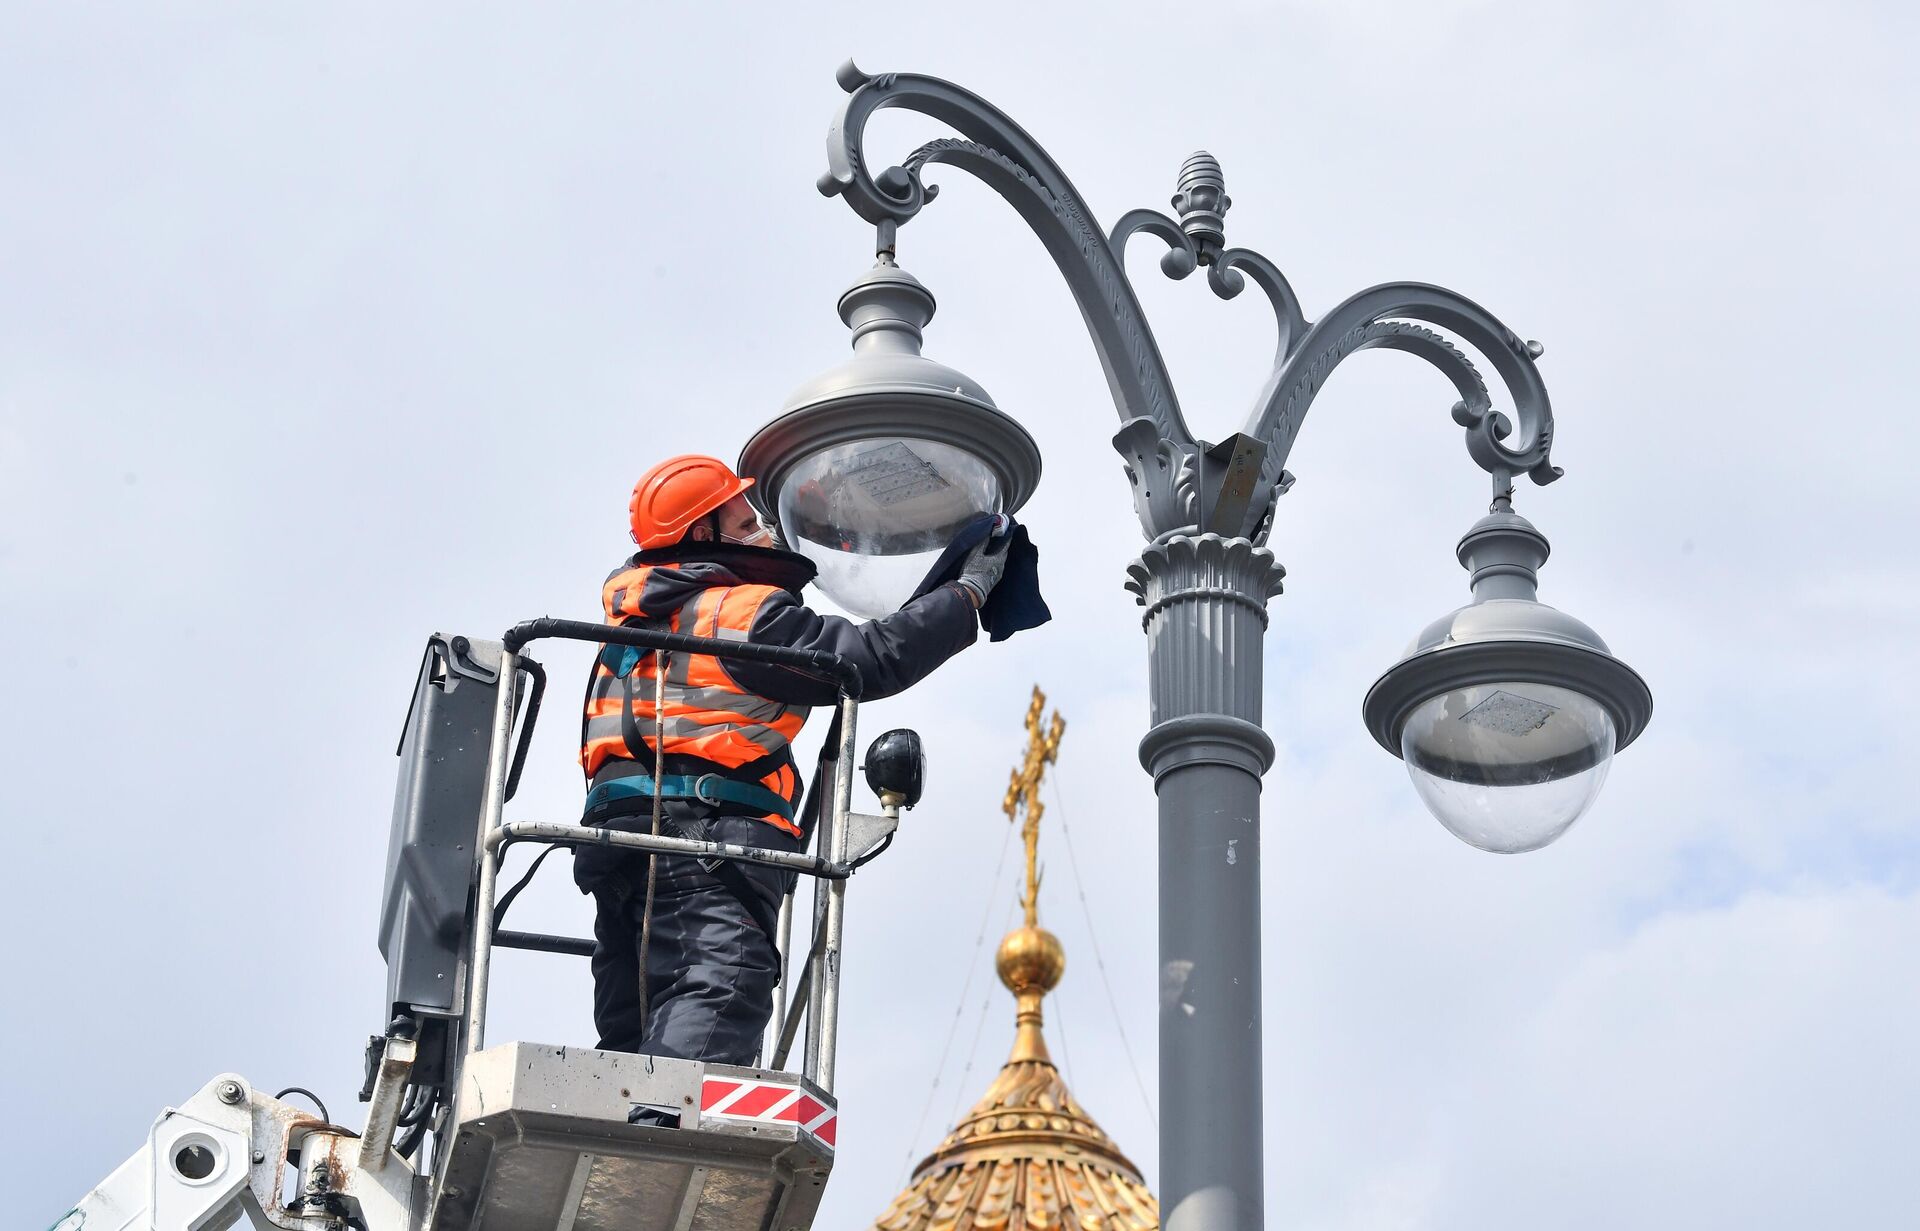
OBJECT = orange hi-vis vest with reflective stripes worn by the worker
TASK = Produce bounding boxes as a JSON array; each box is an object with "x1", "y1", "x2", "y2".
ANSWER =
[{"x1": 580, "y1": 567, "x2": 808, "y2": 837}]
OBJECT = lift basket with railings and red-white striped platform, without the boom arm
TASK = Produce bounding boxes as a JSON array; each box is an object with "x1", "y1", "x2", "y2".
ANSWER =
[{"x1": 408, "y1": 620, "x2": 897, "y2": 1231}]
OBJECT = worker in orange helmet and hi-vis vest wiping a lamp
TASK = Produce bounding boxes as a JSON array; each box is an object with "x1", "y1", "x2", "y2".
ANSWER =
[{"x1": 574, "y1": 455, "x2": 1006, "y2": 1064}]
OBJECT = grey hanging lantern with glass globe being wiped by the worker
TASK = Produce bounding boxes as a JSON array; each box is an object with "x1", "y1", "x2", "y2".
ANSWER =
[{"x1": 739, "y1": 257, "x2": 1041, "y2": 618}]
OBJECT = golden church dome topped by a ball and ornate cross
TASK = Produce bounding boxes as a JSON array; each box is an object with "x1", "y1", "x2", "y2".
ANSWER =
[{"x1": 874, "y1": 688, "x2": 1160, "y2": 1231}]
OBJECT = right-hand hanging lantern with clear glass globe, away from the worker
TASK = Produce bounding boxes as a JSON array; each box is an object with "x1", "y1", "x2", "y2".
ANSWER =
[{"x1": 1363, "y1": 509, "x2": 1653, "y2": 855}]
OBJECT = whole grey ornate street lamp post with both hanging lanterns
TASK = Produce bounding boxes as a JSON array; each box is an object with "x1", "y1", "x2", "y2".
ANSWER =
[{"x1": 741, "y1": 63, "x2": 1653, "y2": 1231}]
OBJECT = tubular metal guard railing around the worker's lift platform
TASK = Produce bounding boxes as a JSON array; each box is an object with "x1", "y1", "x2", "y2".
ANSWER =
[{"x1": 461, "y1": 618, "x2": 860, "y2": 1093}]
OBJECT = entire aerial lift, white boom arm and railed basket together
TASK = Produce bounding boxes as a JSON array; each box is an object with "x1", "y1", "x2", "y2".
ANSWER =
[{"x1": 56, "y1": 620, "x2": 898, "y2": 1231}]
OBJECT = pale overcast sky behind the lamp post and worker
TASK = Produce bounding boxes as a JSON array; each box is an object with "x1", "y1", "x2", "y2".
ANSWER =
[{"x1": 0, "y1": 0, "x2": 1920, "y2": 1231}]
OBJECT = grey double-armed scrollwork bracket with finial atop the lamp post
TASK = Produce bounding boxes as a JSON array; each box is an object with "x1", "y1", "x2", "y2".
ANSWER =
[{"x1": 818, "y1": 61, "x2": 1559, "y2": 542}]
